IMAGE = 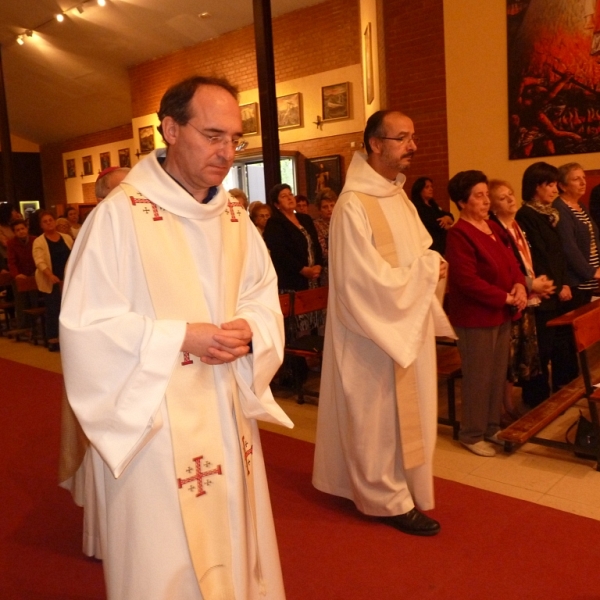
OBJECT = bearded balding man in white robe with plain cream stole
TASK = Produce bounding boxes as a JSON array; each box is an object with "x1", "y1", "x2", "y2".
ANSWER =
[{"x1": 313, "y1": 111, "x2": 454, "y2": 535}]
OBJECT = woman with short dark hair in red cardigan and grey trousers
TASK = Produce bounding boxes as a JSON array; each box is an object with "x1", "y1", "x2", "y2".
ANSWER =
[{"x1": 446, "y1": 171, "x2": 527, "y2": 456}]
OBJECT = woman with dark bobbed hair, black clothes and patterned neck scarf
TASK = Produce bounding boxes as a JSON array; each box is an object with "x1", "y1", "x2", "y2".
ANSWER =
[{"x1": 515, "y1": 162, "x2": 578, "y2": 406}]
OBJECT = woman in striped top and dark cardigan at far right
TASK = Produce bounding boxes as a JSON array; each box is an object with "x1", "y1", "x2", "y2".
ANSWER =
[{"x1": 552, "y1": 163, "x2": 600, "y2": 310}]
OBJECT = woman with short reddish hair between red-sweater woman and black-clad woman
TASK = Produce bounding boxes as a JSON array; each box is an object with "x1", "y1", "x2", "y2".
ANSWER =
[{"x1": 489, "y1": 179, "x2": 556, "y2": 420}]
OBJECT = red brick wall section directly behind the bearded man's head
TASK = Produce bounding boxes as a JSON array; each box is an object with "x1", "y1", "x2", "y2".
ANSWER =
[{"x1": 383, "y1": 0, "x2": 449, "y2": 208}]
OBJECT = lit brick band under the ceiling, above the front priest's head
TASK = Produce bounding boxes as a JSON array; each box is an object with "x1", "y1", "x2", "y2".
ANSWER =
[{"x1": 129, "y1": 0, "x2": 361, "y2": 117}]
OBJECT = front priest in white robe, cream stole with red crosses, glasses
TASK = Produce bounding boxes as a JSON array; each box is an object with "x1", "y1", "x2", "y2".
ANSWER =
[{"x1": 61, "y1": 77, "x2": 292, "y2": 600}]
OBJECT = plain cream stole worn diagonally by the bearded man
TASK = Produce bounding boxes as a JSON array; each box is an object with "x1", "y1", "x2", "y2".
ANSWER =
[{"x1": 354, "y1": 192, "x2": 425, "y2": 469}]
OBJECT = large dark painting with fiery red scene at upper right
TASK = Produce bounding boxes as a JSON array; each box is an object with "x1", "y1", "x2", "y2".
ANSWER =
[{"x1": 506, "y1": 0, "x2": 600, "y2": 159}]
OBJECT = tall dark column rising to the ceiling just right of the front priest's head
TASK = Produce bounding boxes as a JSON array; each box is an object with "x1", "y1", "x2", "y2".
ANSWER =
[{"x1": 252, "y1": 0, "x2": 281, "y2": 197}]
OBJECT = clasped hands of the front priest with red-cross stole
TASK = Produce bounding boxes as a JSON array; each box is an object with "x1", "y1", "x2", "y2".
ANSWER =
[{"x1": 181, "y1": 319, "x2": 252, "y2": 365}]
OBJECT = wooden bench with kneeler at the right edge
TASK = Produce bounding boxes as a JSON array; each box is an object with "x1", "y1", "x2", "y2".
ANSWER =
[{"x1": 498, "y1": 300, "x2": 600, "y2": 470}]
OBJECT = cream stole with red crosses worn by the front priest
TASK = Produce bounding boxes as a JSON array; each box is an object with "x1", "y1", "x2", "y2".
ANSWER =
[{"x1": 121, "y1": 184, "x2": 265, "y2": 600}]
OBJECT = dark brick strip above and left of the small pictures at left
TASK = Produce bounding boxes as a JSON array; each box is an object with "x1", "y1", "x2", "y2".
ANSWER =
[{"x1": 40, "y1": 123, "x2": 133, "y2": 208}]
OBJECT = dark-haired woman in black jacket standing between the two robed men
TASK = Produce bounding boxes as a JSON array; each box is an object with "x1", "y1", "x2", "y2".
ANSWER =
[{"x1": 263, "y1": 183, "x2": 323, "y2": 293}]
